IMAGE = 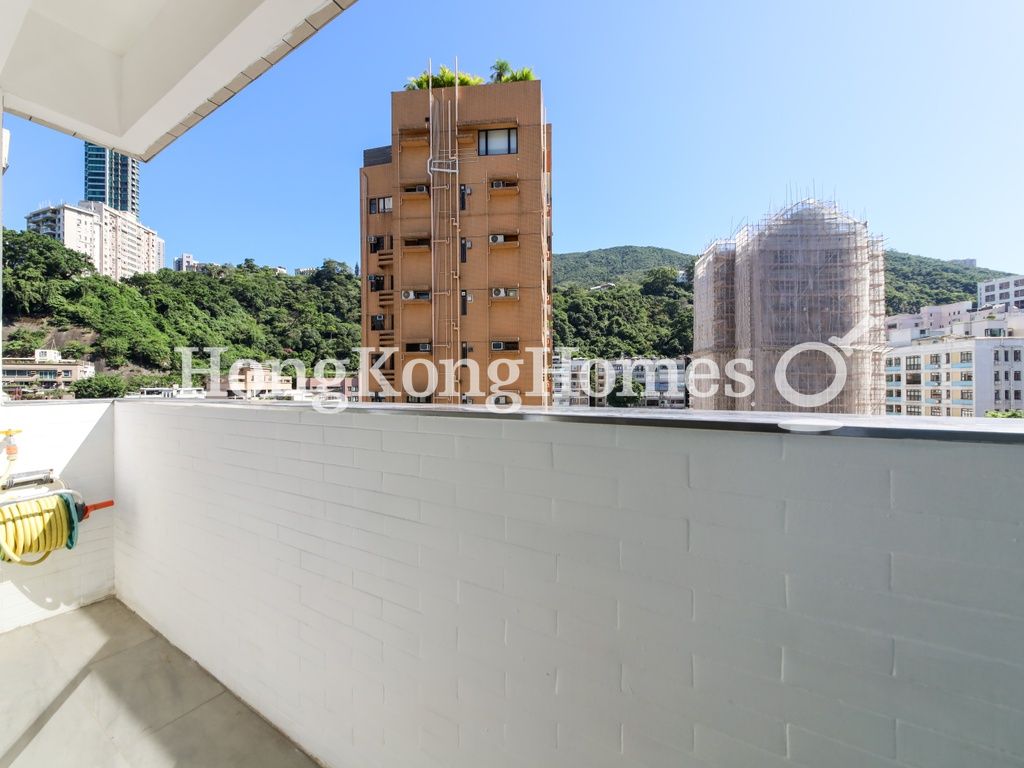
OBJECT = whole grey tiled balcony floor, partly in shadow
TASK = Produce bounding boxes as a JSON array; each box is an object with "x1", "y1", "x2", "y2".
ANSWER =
[{"x1": 0, "y1": 598, "x2": 315, "y2": 768}]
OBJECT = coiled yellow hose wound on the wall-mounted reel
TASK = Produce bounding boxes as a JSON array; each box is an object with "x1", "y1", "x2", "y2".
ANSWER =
[{"x1": 0, "y1": 493, "x2": 78, "y2": 565}]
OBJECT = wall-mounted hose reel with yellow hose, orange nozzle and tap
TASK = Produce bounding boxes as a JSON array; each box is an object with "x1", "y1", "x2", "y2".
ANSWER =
[{"x1": 0, "y1": 429, "x2": 114, "y2": 565}]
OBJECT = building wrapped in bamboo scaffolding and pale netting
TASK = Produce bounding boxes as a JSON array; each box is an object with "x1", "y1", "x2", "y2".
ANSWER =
[{"x1": 690, "y1": 200, "x2": 885, "y2": 415}]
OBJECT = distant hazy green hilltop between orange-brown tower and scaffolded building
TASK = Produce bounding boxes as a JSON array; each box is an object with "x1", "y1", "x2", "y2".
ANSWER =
[{"x1": 554, "y1": 246, "x2": 696, "y2": 288}]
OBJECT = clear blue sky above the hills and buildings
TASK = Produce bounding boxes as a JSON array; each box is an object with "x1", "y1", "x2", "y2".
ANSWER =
[{"x1": 4, "y1": 0, "x2": 1024, "y2": 272}]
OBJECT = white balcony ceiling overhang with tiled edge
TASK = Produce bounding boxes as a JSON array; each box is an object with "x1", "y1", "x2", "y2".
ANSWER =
[{"x1": 0, "y1": 0, "x2": 355, "y2": 160}]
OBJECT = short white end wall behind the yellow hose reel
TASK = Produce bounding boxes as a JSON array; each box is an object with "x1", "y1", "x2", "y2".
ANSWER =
[{"x1": 0, "y1": 402, "x2": 117, "y2": 632}]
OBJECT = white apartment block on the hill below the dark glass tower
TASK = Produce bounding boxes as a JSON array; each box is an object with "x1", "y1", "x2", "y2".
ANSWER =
[{"x1": 25, "y1": 201, "x2": 164, "y2": 280}]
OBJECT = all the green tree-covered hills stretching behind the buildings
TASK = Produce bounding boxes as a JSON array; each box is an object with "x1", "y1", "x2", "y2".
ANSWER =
[{"x1": 3, "y1": 230, "x2": 1002, "y2": 385}]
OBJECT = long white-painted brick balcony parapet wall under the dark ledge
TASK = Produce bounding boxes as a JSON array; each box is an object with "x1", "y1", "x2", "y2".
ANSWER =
[{"x1": 115, "y1": 402, "x2": 1024, "y2": 768}]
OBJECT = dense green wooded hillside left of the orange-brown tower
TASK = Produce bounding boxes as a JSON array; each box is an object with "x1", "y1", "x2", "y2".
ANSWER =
[{"x1": 3, "y1": 229, "x2": 360, "y2": 371}]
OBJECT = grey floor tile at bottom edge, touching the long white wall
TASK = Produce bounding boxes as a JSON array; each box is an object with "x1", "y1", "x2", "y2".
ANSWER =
[{"x1": 117, "y1": 691, "x2": 315, "y2": 768}]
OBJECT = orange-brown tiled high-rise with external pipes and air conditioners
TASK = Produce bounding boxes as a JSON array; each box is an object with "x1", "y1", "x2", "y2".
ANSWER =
[{"x1": 359, "y1": 81, "x2": 551, "y2": 404}]
